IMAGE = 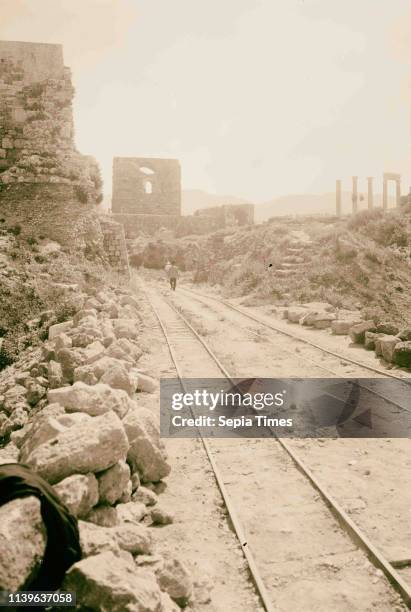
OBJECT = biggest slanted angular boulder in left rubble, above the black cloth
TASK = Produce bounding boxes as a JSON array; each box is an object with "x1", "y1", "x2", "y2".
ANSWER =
[{"x1": 26, "y1": 411, "x2": 129, "y2": 484}]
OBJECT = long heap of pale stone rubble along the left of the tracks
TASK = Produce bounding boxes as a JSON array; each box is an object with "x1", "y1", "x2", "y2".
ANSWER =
[{"x1": 0, "y1": 290, "x2": 192, "y2": 612}]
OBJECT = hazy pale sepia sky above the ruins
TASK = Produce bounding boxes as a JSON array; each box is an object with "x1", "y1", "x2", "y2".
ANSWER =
[{"x1": 0, "y1": 0, "x2": 411, "y2": 202}]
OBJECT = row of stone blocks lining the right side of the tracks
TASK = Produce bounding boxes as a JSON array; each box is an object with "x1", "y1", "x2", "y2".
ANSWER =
[{"x1": 283, "y1": 302, "x2": 411, "y2": 369}]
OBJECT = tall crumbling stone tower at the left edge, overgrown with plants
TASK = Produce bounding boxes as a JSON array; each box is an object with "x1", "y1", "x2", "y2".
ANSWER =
[{"x1": 0, "y1": 41, "x2": 102, "y2": 247}]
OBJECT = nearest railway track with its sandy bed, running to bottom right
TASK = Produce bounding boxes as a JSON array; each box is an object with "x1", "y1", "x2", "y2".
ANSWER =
[{"x1": 145, "y1": 280, "x2": 411, "y2": 612}]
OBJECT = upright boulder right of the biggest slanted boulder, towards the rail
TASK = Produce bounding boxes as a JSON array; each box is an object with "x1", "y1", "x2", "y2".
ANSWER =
[{"x1": 123, "y1": 406, "x2": 171, "y2": 482}]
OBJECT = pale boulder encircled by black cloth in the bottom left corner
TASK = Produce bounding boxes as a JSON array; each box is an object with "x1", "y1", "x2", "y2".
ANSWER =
[{"x1": 0, "y1": 496, "x2": 47, "y2": 591}]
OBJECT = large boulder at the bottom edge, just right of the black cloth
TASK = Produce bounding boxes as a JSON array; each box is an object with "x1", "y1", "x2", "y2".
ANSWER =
[{"x1": 62, "y1": 552, "x2": 161, "y2": 612}]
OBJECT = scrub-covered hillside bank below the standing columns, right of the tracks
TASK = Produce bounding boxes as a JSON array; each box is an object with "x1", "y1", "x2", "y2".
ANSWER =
[{"x1": 130, "y1": 206, "x2": 411, "y2": 323}]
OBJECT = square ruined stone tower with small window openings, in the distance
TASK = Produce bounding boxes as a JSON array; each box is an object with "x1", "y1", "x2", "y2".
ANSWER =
[{"x1": 112, "y1": 157, "x2": 181, "y2": 216}]
